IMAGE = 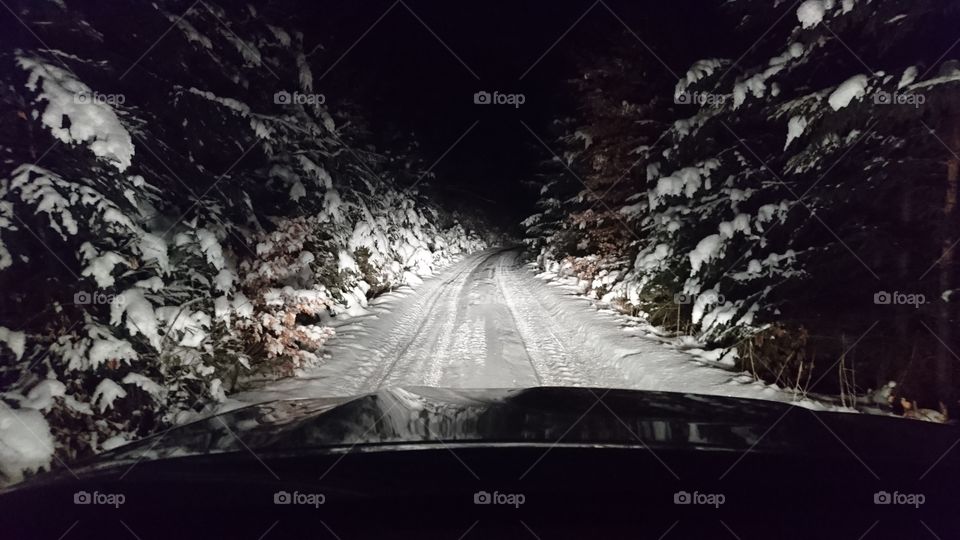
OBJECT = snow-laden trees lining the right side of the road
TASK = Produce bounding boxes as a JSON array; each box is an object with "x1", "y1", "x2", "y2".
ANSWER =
[{"x1": 525, "y1": 0, "x2": 960, "y2": 409}]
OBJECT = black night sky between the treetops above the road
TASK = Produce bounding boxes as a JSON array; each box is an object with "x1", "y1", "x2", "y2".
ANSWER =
[{"x1": 282, "y1": 0, "x2": 732, "y2": 222}]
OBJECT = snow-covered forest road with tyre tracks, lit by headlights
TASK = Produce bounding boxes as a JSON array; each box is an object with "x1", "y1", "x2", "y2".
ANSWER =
[{"x1": 231, "y1": 248, "x2": 808, "y2": 403}]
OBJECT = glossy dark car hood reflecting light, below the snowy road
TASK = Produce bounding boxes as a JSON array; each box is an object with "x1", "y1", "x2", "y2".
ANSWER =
[{"x1": 7, "y1": 387, "x2": 958, "y2": 488}]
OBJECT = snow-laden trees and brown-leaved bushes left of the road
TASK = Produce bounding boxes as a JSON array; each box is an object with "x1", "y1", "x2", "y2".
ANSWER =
[{"x1": 0, "y1": 1, "x2": 485, "y2": 482}]
